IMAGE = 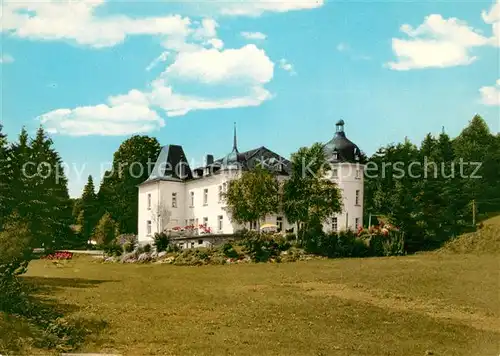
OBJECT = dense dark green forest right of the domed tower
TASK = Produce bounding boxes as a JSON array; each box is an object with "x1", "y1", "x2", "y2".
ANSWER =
[{"x1": 365, "y1": 115, "x2": 500, "y2": 252}]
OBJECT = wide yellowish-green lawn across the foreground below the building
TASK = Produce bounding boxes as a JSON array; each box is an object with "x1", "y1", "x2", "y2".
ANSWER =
[{"x1": 9, "y1": 254, "x2": 500, "y2": 356}]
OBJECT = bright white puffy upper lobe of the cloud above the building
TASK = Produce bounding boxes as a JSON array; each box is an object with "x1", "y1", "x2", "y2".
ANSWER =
[{"x1": 163, "y1": 44, "x2": 274, "y2": 85}]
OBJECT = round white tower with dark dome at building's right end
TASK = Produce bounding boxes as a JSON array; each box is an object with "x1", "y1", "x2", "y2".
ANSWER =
[{"x1": 324, "y1": 120, "x2": 364, "y2": 231}]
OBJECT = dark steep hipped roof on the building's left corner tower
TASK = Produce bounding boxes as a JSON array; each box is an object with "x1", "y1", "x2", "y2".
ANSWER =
[{"x1": 142, "y1": 145, "x2": 193, "y2": 184}]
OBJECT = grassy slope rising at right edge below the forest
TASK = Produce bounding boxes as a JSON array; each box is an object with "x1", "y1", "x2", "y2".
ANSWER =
[{"x1": 437, "y1": 215, "x2": 500, "y2": 254}]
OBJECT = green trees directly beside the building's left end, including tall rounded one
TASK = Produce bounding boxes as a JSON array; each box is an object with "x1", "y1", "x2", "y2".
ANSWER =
[{"x1": 72, "y1": 135, "x2": 161, "y2": 246}]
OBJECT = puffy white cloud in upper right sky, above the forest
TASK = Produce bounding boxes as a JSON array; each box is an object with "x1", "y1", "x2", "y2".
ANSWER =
[{"x1": 387, "y1": 14, "x2": 489, "y2": 70}]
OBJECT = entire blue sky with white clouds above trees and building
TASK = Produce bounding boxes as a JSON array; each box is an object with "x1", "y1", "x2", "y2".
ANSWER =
[{"x1": 0, "y1": 0, "x2": 500, "y2": 196}]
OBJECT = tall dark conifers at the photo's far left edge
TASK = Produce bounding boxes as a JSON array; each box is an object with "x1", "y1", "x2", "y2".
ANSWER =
[{"x1": 0, "y1": 125, "x2": 72, "y2": 249}]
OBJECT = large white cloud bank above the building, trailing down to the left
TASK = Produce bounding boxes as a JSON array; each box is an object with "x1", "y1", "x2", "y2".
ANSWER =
[{"x1": 38, "y1": 45, "x2": 274, "y2": 136}]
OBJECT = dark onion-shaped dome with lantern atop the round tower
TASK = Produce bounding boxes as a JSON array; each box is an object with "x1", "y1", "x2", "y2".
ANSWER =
[{"x1": 323, "y1": 120, "x2": 361, "y2": 163}]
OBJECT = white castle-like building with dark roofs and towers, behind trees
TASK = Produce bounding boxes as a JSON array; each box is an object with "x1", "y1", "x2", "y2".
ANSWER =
[{"x1": 138, "y1": 121, "x2": 364, "y2": 247}]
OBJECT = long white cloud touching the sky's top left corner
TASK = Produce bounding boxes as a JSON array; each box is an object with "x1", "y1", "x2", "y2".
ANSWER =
[{"x1": 1, "y1": 0, "x2": 193, "y2": 48}]
